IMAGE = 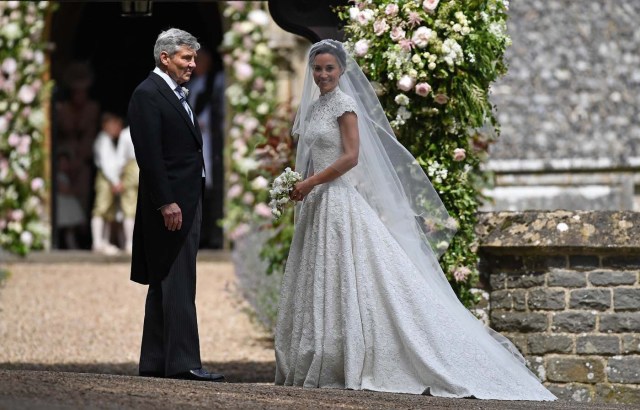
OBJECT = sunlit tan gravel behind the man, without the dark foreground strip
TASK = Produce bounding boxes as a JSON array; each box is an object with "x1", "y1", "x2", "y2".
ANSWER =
[{"x1": 0, "y1": 262, "x2": 274, "y2": 382}]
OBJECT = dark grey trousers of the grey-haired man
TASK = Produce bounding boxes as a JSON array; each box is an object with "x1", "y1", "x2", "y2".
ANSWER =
[{"x1": 139, "y1": 201, "x2": 202, "y2": 376}]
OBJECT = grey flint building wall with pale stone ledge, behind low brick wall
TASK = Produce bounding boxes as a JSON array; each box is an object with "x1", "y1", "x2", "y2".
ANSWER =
[{"x1": 485, "y1": 0, "x2": 640, "y2": 211}]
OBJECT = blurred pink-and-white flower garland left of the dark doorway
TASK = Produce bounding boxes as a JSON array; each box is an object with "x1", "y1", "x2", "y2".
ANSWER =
[{"x1": 0, "y1": 1, "x2": 51, "y2": 255}]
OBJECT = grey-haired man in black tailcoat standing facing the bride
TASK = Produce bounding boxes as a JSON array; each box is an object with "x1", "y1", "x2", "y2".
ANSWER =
[{"x1": 129, "y1": 28, "x2": 224, "y2": 381}]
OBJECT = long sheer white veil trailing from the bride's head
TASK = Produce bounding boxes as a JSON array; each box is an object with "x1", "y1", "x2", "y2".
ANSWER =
[{"x1": 292, "y1": 40, "x2": 535, "y2": 377}]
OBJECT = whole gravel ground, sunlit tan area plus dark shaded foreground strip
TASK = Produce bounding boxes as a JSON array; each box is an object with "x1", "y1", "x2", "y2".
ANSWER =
[{"x1": 0, "y1": 254, "x2": 638, "y2": 410}]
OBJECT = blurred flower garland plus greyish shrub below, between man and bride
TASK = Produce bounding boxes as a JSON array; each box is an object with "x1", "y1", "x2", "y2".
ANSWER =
[{"x1": 222, "y1": 1, "x2": 294, "y2": 329}]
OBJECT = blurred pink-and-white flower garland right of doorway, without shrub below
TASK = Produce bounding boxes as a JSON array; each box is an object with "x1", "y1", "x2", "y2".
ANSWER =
[{"x1": 222, "y1": 1, "x2": 293, "y2": 241}]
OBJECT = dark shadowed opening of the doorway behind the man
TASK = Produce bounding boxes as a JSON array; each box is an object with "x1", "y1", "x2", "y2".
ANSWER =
[{"x1": 50, "y1": 2, "x2": 223, "y2": 249}]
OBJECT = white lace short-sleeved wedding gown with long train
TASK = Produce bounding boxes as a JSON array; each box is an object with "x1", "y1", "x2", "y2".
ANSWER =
[{"x1": 275, "y1": 89, "x2": 555, "y2": 400}]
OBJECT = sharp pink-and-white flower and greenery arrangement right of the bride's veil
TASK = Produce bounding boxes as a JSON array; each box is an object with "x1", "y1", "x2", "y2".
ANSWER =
[{"x1": 338, "y1": 0, "x2": 510, "y2": 306}]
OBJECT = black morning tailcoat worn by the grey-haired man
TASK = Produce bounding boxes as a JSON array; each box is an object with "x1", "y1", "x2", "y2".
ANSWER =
[{"x1": 128, "y1": 72, "x2": 204, "y2": 284}]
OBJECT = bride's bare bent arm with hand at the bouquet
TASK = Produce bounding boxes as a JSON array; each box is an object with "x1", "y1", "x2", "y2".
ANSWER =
[{"x1": 291, "y1": 112, "x2": 360, "y2": 201}]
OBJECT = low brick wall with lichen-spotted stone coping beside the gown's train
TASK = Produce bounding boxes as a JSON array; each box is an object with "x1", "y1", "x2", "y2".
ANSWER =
[{"x1": 477, "y1": 211, "x2": 640, "y2": 404}]
